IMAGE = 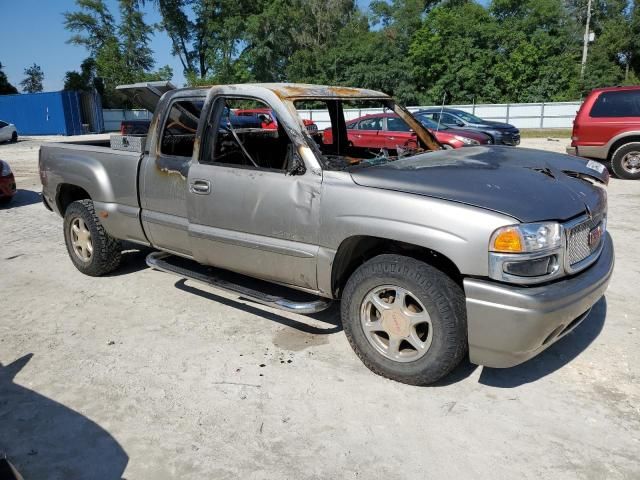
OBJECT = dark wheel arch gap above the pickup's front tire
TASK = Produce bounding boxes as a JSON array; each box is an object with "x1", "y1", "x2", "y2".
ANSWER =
[{"x1": 331, "y1": 235, "x2": 463, "y2": 298}]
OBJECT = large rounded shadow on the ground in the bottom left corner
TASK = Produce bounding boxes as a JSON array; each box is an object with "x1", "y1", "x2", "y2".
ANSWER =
[{"x1": 0, "y1": 354, "x2": 129, "y2": 480}]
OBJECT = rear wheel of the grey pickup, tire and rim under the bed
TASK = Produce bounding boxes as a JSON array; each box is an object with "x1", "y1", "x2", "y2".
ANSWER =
[{"x1": 64, "y1": 200, "x2": 122, "y2": 277}]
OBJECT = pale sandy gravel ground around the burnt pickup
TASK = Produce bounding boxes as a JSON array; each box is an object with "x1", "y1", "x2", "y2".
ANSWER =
[{"x1": 0, "y1": 135, "x2": 640, "y2": 480}]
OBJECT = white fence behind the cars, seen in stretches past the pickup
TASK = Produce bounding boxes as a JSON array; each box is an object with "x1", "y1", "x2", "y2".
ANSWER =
[{"x1": 103, "y1": 102, "x2": 580, "y2": 132}]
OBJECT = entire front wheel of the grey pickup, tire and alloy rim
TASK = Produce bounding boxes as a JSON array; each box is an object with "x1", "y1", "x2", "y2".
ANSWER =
[{"x1": 341, "y1": 255, "x2": 467, "y2": 385}]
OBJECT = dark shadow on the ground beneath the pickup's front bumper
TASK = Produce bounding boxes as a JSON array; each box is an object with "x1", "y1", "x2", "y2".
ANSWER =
[{"x1": 432, "y1": 297, "x2": 607, "y2": 388}]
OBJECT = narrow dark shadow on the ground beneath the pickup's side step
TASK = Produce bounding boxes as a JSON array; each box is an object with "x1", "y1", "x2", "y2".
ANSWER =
[{"x1": 175, "y1": 279, "x2": 342, "y2": 335}]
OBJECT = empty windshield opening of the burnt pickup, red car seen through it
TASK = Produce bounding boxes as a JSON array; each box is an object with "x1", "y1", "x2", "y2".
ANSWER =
[{"x1": 293, "y1": 98, "x2": 441, "y2": 170}]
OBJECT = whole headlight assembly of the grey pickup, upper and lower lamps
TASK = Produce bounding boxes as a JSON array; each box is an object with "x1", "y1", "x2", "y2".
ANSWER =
[{"x1": 489, "y1": 222, "x2": 563, "y2": 284}]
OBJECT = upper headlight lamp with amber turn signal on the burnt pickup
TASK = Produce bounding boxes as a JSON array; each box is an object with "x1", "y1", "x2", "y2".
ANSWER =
[{"x1": 489, "y1": 222, "x2": 562, "y2": 253}]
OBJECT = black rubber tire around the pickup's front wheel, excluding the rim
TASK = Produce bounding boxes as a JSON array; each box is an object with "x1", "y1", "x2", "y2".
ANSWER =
[{"x1": 341, "y1": 255, "x2": 468, "y2": 385}]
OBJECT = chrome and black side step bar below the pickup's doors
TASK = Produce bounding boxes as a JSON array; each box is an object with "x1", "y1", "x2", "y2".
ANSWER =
[{"x1": 146, "y1": 252, "x2": 332, "y2": 314}]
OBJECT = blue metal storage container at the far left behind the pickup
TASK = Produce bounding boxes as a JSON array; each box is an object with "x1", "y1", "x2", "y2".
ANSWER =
[{"x1": 0, "y1": 91, "x2": 90, "y2": 135}]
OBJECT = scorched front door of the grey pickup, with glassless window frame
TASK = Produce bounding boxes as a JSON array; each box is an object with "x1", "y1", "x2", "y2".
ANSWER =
[{"x1": 187, "y1": 91, "x2": 322, "y2": 290}]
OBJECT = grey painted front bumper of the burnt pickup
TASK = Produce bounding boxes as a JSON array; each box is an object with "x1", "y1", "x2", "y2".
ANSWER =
[{"x1": 464, "y1": 233, "x2": 614, "y2": 368}]
